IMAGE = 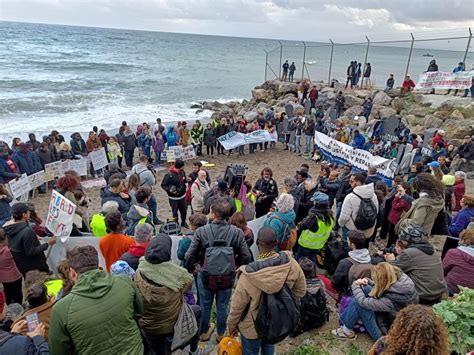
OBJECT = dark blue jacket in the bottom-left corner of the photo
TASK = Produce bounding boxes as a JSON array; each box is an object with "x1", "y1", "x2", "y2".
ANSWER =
[{"x1": 0, "y1": 330, "x2": 49, "y2": 355}]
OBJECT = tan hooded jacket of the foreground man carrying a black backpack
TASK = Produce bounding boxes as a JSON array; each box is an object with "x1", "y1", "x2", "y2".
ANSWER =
[{"x1": 227, "y1": 252, "x2": 306, "y2": 339}]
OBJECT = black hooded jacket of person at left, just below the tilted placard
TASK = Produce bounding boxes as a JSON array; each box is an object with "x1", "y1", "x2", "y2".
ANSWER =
[{"x1": 3, "y1": 222, "x2": 49, "y2": 276}]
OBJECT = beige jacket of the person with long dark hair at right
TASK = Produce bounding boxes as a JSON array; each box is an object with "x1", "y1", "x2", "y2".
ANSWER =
[{"x1": 395, "y1": 192, "x2": 444, "y2": 236}]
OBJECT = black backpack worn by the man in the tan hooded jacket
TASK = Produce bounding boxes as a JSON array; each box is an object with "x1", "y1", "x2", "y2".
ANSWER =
[{"x1": 254, "y1": 283, "x2": 300, "y2": 344}]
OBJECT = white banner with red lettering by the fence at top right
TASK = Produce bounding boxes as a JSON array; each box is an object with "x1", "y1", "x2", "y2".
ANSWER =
[{"x1": 415, "y1": 70, "x2": 474, "y2": 90}]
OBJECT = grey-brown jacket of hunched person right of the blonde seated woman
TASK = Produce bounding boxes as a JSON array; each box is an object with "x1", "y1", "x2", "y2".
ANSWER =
[{"x1": 392, "y1": 240, "x2": 446, "y2": 301}]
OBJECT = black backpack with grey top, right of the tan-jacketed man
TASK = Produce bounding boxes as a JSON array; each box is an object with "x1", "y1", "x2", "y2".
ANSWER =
[{"x1": 291, "y1": 279, "x2": 329, "y2": 337}]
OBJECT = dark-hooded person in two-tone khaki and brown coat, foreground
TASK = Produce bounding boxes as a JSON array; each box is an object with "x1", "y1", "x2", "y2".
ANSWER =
[{"x1": 135, "y1": 233, "x2": 201, "y2": 354}]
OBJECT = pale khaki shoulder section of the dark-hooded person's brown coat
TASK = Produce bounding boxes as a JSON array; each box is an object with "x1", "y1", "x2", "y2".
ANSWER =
[{"x1": 137, "y1": 257, "x2": 193, "y2": 292}]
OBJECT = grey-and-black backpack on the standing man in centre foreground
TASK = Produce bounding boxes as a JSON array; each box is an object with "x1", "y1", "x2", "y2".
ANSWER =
[{"x1": 202, "y1": 224, "x2": 235, "y2": 291}]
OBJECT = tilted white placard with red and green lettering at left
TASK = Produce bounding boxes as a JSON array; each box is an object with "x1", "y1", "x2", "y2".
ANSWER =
[{"x1": 45, "y1": 190, "x2": 76, "y2": 243}]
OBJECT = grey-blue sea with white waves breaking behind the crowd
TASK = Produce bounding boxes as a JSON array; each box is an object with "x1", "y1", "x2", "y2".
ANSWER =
[{"x1": 0, "y1": 22, "x2": 472, "y2": 141}]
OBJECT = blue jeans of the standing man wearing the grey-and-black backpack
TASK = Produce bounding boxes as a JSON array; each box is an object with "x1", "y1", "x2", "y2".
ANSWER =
[{"x1": 197, "y1": 272, "x2": 232, "y2": 335}]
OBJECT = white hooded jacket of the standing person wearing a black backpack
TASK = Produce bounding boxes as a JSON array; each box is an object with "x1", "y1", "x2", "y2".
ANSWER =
[{"x1": 339, "y1": 183, "x2": 379, "y2": 238}]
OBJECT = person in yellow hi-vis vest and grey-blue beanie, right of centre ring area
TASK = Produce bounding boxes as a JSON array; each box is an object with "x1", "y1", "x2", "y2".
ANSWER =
[{"x1": 296, "y1": 191, "x2": 334, "y2": 263}]
